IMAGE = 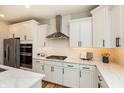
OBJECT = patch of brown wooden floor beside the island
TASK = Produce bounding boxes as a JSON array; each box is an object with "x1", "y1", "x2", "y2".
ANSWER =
[{"x1": 42, "y1": 81, "x2": 64, "y2": 88}]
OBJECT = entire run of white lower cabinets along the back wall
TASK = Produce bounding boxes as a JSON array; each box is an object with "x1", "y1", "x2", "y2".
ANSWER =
[{"x1": 33, "y1": 60, "x2": 97, "y2": 88}]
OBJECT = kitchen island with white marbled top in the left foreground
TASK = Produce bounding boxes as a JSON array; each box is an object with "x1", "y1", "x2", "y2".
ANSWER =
[{"x1": 0, "y1": 65, "x2": 44, "y2": 88}]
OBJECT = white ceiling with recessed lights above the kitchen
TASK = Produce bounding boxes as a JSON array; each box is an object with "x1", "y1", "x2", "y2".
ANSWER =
[{"x1": 0, "y1": 5, "x2": 96, "y2": 23}]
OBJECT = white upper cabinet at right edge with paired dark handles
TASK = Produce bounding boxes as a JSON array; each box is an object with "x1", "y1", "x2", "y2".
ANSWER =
[{"x1": 111, "y1": 5, "x2": 124, "y2": 48}]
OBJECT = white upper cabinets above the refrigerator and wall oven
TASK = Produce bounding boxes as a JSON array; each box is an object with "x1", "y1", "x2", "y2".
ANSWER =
[{"x1": 9, "y1": 20, "x2": 38, "y2": 41}]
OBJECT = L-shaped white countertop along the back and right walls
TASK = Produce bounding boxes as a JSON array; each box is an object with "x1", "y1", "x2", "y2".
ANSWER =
[{"x1": 34, "y1": 57, "x2": 124, "y2": 88}]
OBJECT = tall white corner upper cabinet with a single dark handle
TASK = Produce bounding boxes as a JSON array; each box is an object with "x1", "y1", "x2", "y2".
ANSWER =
[{"x1": 91, "y1": 6, "x2": 111, "y2": 48}]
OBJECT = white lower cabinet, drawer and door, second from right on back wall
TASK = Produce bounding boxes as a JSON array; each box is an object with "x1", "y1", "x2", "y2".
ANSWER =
[{"x1": 63, "y1": 63, "x2": 79, "y2": 88}]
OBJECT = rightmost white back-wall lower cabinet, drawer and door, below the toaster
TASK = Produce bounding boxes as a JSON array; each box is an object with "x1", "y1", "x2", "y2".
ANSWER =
[{"x1": 80, "y1": 65, "x2": 97, "y2": 88}]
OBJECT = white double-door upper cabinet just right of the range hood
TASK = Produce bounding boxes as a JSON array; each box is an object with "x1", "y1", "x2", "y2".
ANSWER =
[{"x1": 70, "y1": 17, "x2": 92, "y2": 48}]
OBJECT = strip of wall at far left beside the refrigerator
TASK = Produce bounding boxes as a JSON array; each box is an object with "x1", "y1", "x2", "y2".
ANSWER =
[{"x1": 0, "y1": 21, "x2": 8, "y2": 64}]
